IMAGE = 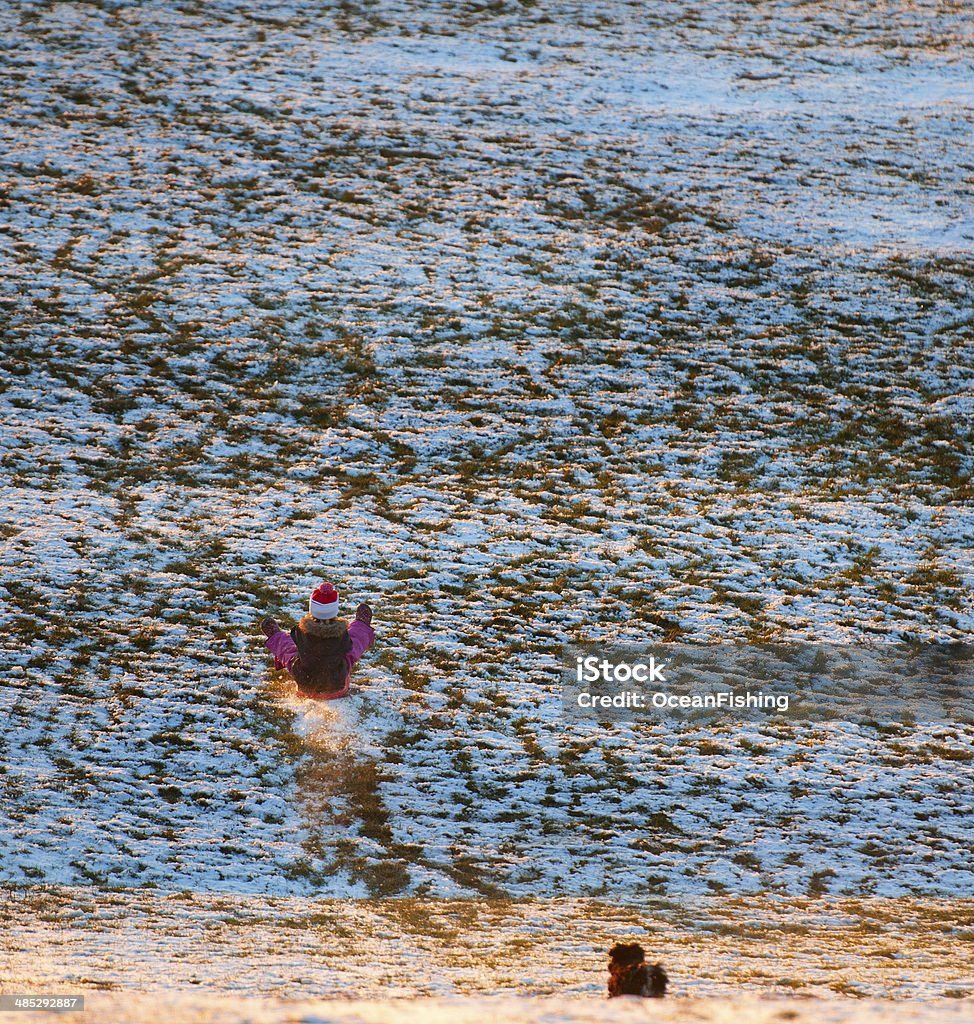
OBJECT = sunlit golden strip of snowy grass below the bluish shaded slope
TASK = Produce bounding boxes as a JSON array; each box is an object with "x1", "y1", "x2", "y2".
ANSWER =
[{"x1": 0, "y1": 887, "x2": 974, "y2": 1011}]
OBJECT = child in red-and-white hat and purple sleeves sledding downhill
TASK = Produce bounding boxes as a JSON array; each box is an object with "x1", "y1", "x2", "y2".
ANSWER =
[{"x1": 260, "y1": 583, "x2": 376, "y2": 700}]
